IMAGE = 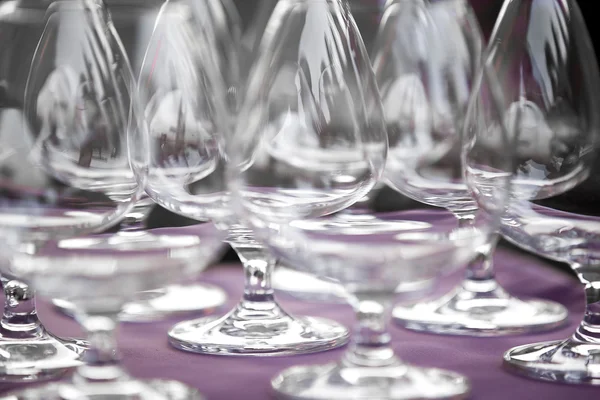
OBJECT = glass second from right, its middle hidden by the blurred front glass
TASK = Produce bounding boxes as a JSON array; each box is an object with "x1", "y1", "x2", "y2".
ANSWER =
[{"x1": 373, "y1": 0, "x2": 567, "y2": 336}]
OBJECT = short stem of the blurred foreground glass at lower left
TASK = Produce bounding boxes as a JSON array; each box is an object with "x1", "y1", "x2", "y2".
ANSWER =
[{"x1": 73, "y1": 307, "x2": 129, "y2": 385}]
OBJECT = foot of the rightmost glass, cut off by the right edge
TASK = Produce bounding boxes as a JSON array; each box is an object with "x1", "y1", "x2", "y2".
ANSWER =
[{"x1": 504, "y1": 339, "x2": 600, "y2": 385}]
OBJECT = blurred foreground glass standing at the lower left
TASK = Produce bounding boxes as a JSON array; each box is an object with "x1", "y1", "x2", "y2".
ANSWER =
[{"x1": 0, "y1": 0, "x2": 222, "y2": 400}]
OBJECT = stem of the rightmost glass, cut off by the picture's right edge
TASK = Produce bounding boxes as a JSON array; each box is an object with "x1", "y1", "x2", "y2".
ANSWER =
[{"x1": 572, "y1": 264, "x2": 600, "y2": 344}]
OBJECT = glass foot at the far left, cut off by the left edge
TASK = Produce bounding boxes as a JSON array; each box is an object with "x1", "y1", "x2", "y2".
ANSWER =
[{"x1": 0, "y1": 331, "x2": 87, "y2": 382}]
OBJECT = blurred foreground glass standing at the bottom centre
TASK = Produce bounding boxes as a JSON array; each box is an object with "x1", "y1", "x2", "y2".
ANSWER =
[{"x1": 230, "y1": 0, "x2": 513, "y2": 400}]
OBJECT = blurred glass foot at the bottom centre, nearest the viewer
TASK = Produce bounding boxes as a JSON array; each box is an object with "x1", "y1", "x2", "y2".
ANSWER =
[{"x1": 271, "y1": 364, "x2": 470, "y2": 400}]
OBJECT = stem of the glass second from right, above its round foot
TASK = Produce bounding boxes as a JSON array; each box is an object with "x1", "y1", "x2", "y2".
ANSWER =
[{"x1": 454, "y1": 212, "x2": 501, "y2": 293}]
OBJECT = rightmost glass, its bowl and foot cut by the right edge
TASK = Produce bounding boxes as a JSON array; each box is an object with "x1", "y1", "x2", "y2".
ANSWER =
[{"x1": 474, "y1": 0, "x2": 600, "y2": 385}]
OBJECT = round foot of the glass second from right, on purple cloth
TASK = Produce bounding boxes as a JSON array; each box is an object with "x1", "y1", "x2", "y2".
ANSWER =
[{"x1": 393, "y1": 282, "x2": 568, "y2": 336}]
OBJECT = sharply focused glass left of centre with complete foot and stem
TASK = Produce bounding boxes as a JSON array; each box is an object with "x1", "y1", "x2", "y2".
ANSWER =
[{"x1": 139, "y1": 2, "x2": 348, "y2": 356}]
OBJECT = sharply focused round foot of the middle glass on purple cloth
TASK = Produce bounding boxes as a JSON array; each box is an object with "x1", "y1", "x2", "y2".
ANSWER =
[{"x1": 169, "y1": 300, "x2": 349, "y2": 356}]
